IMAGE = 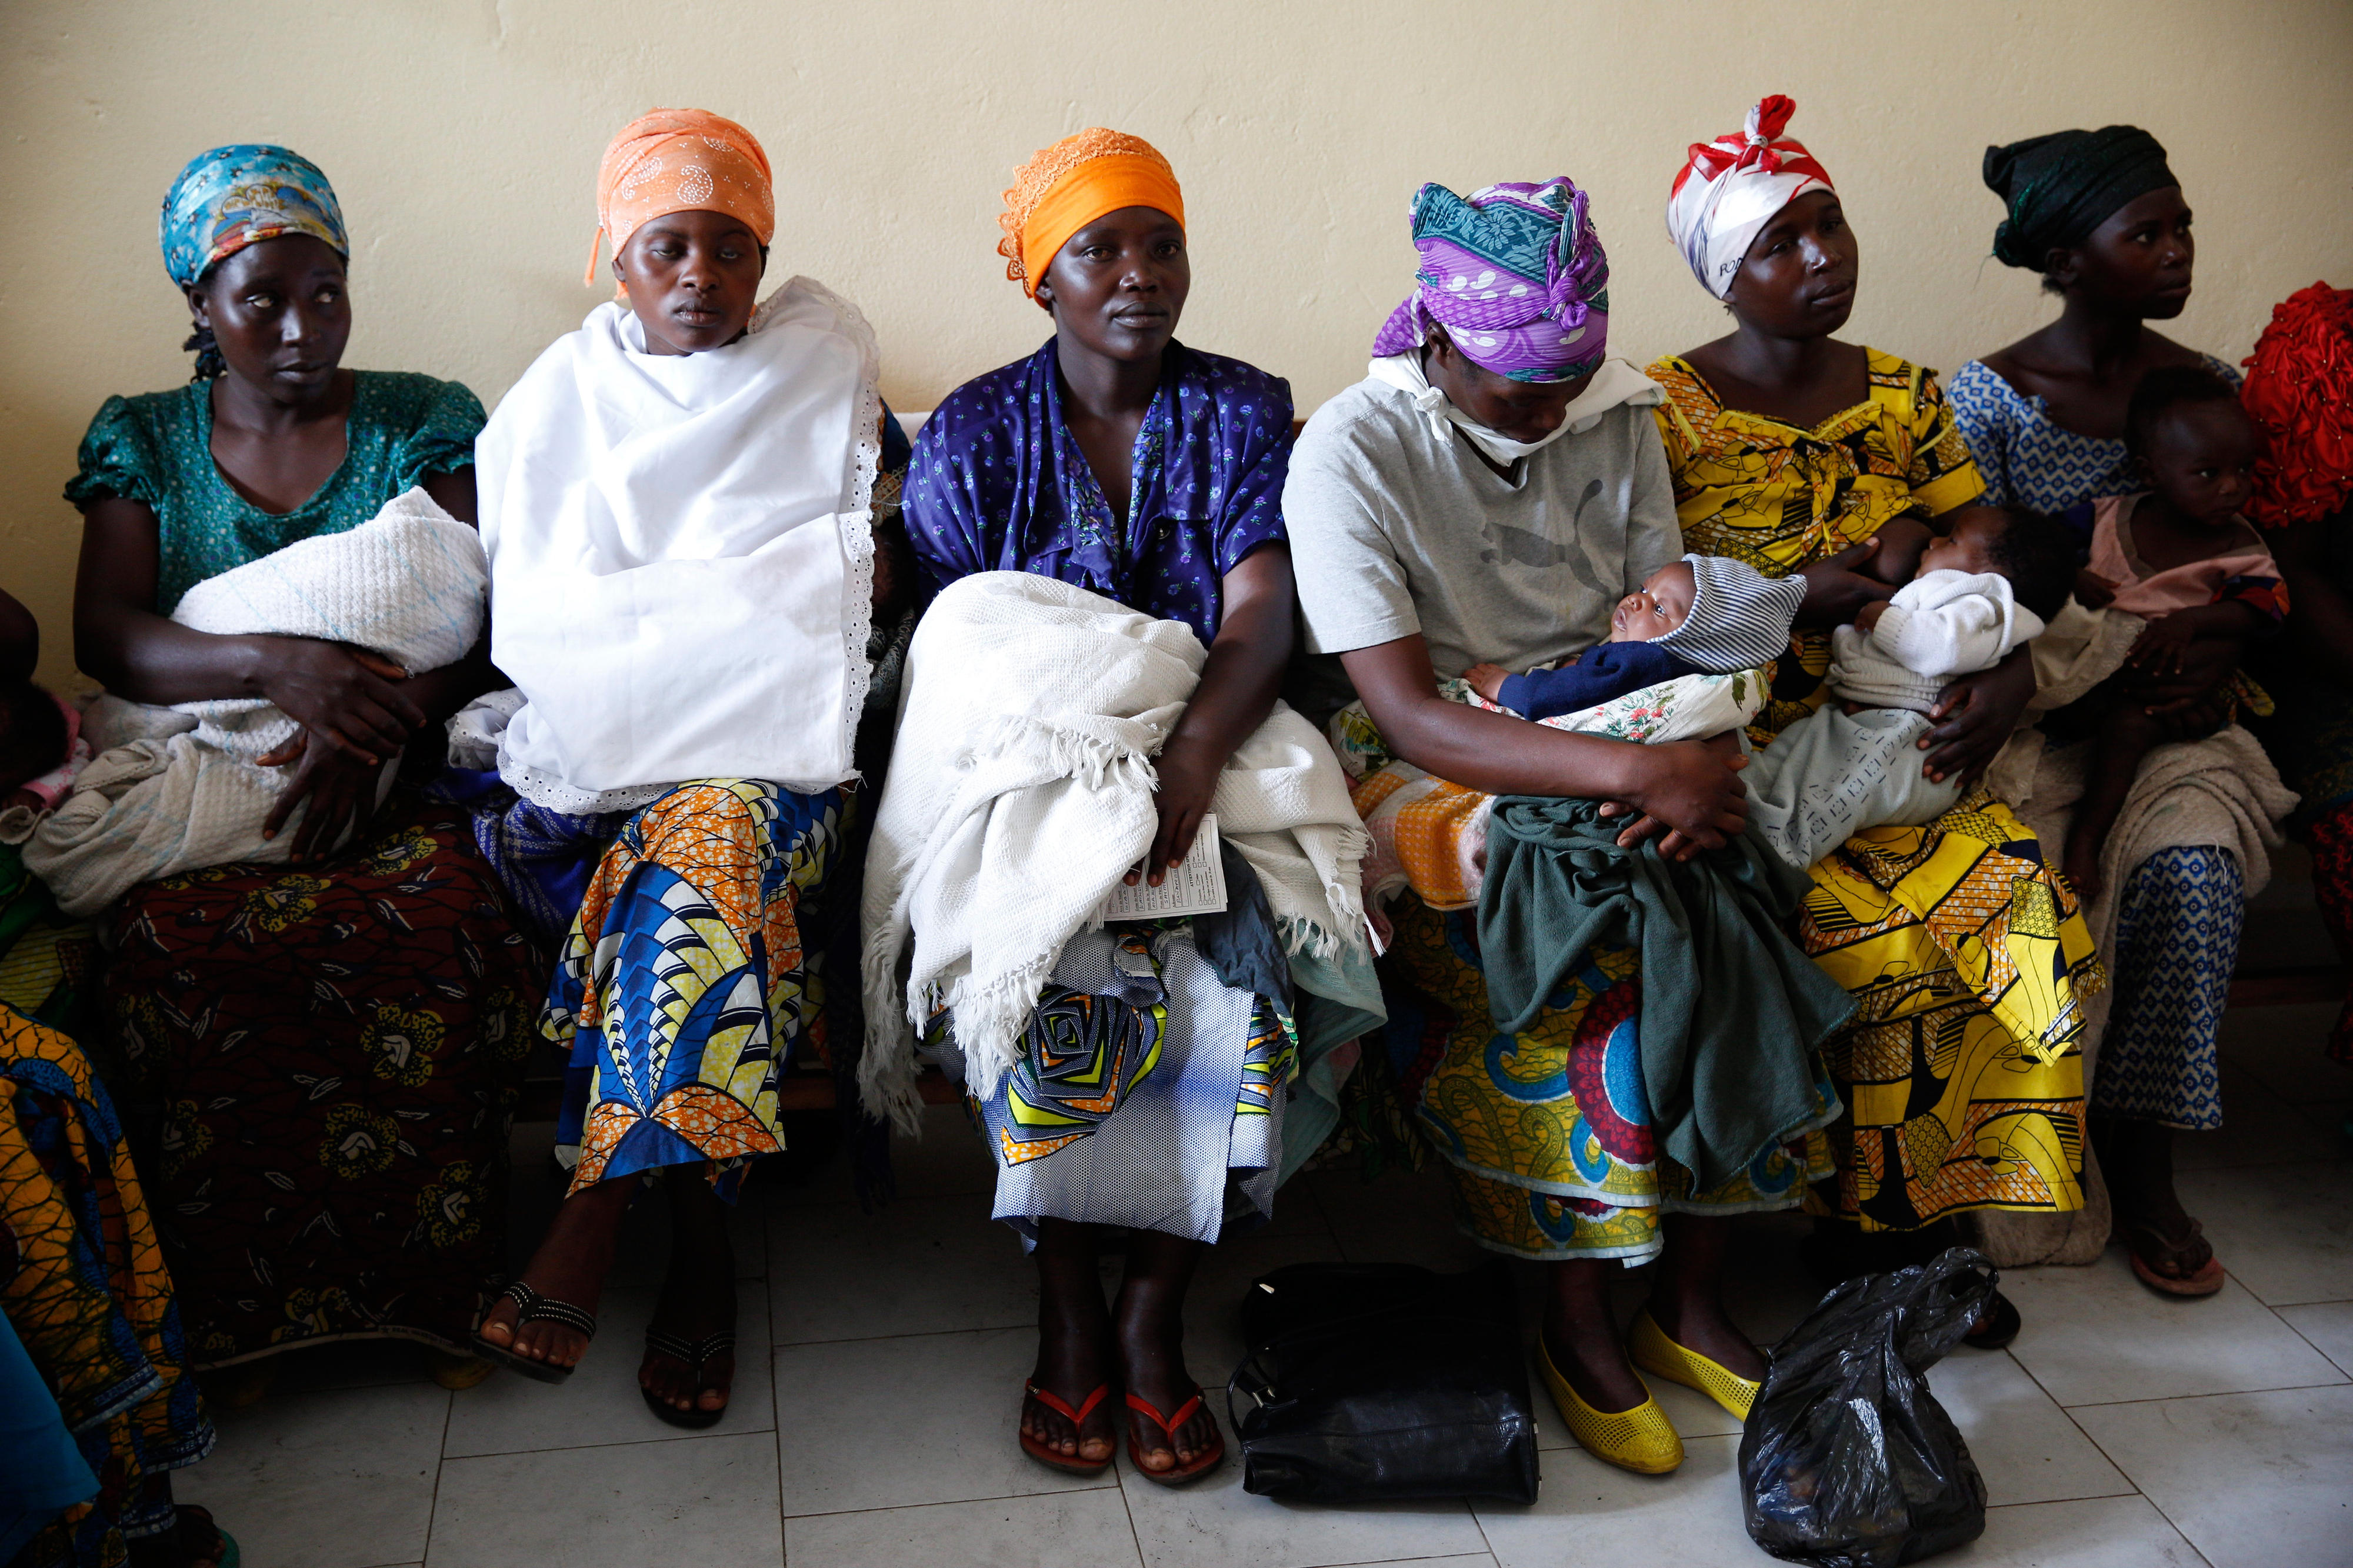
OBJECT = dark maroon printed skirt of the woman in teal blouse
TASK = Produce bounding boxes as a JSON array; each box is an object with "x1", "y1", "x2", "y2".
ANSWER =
[{"x1": 106, "y1": 796, "x2": 539, "y2": 1366}]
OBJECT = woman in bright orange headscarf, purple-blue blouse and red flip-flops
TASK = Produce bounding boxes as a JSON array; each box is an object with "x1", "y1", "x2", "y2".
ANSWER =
[{"x1": 889, "y1": 129, "x2": 1379, "y2": 1481}]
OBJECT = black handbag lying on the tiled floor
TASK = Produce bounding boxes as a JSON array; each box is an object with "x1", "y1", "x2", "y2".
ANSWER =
[{"x1": 1226, "y1": 1260, "x2": 1537, "y2": 1502}]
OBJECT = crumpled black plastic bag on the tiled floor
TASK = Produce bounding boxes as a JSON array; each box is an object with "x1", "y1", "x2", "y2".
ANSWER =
[{"x1": 1741, "y1": 1248, "x2": 2000, "y2": 1568}]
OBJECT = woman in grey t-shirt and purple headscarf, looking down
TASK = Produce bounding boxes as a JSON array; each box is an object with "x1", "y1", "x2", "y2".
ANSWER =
[{"x1": 1282, "y1": 176, "x2": 1788, "y2": 1474}]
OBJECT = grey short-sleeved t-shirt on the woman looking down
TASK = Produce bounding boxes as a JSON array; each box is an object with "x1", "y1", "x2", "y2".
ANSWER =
[{"x1": 1282, "y1": 379, "x2": 1682, "y2": 676}]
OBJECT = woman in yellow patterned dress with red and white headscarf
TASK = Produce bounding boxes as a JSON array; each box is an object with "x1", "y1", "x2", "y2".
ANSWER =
[{"x1": 1649, "y1": 96, "x2": 2099, "y2": 1318}]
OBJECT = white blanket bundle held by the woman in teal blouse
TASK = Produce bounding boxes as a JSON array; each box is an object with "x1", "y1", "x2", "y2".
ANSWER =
[{"x1": 24, "y1": 490, "x2": 487, "y2": 916}]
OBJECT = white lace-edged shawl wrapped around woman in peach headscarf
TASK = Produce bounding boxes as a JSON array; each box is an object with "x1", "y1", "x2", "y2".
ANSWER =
[{"x1": 475, "y1": 278, "x2": 882, "y2": 812}]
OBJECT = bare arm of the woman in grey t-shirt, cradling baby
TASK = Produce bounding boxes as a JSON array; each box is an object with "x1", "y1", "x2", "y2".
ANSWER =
[{"x1": 1341, "y1": 633, "x2": 1748, "y2": 859}]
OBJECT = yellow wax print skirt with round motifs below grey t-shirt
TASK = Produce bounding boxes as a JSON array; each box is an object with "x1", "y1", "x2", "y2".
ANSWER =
[{"x1": 1377, "y1": 895, "x2": 1838, "y2": 1265}]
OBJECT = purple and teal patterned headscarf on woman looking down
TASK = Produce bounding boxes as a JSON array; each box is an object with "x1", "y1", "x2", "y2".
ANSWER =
[{"x1": 1372, "y1": 174, "x2": 1609, "y2": 381}]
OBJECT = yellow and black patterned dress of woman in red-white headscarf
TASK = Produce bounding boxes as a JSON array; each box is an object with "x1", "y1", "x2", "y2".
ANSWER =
[{"x1": 1649, "y1": 351, "x2": 2106, "y2": 1229}]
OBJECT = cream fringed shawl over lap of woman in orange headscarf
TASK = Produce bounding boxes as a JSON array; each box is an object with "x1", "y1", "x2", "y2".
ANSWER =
[{"x1": 859, "y1": 572, "x2": 1365, "y2": 1130}]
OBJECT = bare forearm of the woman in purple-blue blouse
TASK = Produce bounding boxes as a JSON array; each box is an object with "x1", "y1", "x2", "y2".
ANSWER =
[{"x1": 1129, "y1": 544, "x2": 1292, "y2": 871}]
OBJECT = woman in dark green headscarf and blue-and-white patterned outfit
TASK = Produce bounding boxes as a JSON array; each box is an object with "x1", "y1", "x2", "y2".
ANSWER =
[{"x1": 1953, "y1": 125, "x2": 2249, "y2": 1295}]
